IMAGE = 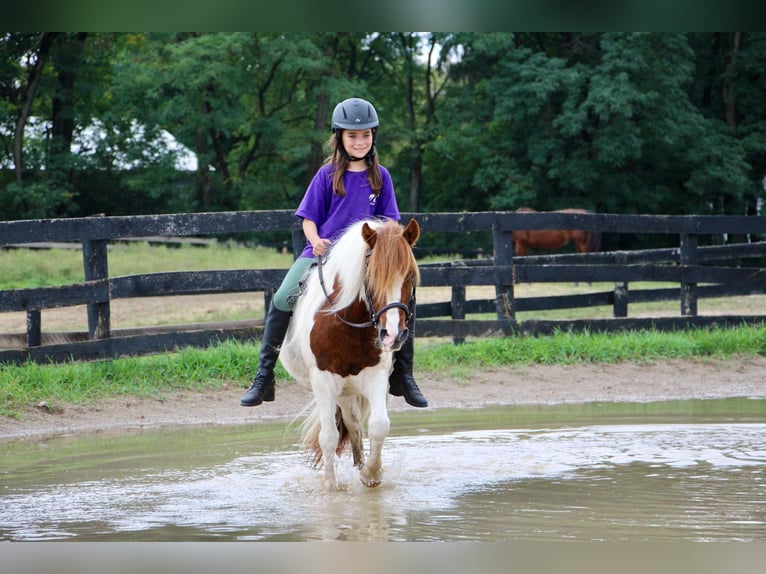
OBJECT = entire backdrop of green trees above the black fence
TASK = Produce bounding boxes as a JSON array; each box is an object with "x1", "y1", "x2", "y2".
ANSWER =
[{"x1": 0, "y1": 32, "x2": 766, "y2": 236}]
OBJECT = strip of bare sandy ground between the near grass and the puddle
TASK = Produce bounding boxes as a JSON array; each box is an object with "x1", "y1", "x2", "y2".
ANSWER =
[{"x1": 0, "y1": 357, "x2": 766, "y2": 441}]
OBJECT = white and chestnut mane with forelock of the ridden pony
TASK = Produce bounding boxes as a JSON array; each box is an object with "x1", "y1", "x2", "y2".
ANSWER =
[{"x1": 324, "y1": 219, "x2": 420, "y2": 312}]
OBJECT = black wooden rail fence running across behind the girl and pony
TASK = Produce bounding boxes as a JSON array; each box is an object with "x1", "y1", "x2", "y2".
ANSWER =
[{"x1": 0, "y1": 210, "x2": 766, "y2": 363}]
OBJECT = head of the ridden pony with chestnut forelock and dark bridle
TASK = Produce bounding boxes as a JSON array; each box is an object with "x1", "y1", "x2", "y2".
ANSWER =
[{"x1": 362, "y1": 219, "x2": 420, "y2": 351}]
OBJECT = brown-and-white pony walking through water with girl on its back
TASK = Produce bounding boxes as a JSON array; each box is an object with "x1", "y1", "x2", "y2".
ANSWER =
[{"x1": 280, "y1": 219, "x2": 420, "y2": 490}]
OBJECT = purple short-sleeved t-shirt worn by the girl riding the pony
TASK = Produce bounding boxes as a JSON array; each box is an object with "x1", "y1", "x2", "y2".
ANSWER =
[{"x1": 295, "y1": 164, "x2": 401, "y2": 257}]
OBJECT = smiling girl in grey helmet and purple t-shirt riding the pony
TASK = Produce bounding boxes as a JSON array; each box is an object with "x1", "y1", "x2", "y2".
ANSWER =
[{"x1": 240, "y1": 98, "x2": 428, "y2": 407}]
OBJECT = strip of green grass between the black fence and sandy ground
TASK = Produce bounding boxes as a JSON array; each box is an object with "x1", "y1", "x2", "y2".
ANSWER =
[{"x1": 0, "y1": 326, "x2": 766, "y2": 417}]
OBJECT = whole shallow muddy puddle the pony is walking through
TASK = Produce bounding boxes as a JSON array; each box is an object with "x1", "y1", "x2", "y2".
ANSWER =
[{"x1": 0, "y1": 399, "x2": 766, "y2": 541}]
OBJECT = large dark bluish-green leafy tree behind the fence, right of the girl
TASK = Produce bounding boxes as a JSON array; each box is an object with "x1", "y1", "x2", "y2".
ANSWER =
[{"x1": 456, "y1": 33, "x2": 746, "y2": 219}]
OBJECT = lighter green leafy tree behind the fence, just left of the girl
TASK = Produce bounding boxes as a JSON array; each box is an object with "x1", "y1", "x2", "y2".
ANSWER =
[{"x1": 114, "y1": 33, "x2": 342, "y2": 210}]
